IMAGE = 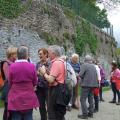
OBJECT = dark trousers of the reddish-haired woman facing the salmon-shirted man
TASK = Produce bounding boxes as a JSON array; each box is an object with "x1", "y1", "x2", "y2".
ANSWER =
[{"x1": 36, "y1": 87, "x2": 48, "y2": 120}]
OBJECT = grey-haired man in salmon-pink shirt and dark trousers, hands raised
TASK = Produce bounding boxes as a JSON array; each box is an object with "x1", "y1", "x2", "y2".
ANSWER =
[{"x1": 39, "y1": 45, "x2": 69, "y2": 120}]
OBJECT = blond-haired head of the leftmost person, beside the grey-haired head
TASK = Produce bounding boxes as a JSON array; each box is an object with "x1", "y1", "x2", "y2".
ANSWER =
[{"x1": 6, "y1": 46, "x2": 17, "y2": 62}]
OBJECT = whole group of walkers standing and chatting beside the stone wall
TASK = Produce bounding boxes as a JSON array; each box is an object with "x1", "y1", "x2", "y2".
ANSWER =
[{"x1": 1, "y1": 45, "x2": 120, "y2": 120}]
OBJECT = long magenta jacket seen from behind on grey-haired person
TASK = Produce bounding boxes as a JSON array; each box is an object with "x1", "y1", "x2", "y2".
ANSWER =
[{"x1": 8, "y1": 61, "x2": 39, "y2": 111}]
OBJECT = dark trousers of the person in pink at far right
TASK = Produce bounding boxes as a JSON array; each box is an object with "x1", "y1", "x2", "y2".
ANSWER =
[{"x1": 111, "y1": 82, "x2": 120, "y2": 102}]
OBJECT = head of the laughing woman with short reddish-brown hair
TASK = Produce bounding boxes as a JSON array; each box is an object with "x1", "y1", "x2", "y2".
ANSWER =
[{"x1": 38, "y1": 48, "x2": 48, "y2": 61}]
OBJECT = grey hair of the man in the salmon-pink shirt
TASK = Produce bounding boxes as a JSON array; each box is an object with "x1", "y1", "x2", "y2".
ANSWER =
[{"x1": 49, "y1": 45, "x2": 62, "y2": 57}]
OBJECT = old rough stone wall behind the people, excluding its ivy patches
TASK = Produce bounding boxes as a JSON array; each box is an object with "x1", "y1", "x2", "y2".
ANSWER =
[{"x1": 0, "y1": 0, "x2": 116, "y2": 79}]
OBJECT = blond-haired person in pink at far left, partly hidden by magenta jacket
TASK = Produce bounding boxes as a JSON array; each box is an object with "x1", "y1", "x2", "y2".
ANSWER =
[{"x1": 1, "y1": 46, "x2": 17, "y2": 120}]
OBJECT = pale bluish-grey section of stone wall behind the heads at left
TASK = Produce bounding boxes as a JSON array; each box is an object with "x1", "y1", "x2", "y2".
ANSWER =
[{"x1": 0, "y1": 26, "x2": 48, "y2": 63}]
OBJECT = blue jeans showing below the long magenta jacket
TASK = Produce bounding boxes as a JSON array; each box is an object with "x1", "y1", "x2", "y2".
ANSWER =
[{"x1": 12, "y1": 110, "x2": 33, "y2": 120}]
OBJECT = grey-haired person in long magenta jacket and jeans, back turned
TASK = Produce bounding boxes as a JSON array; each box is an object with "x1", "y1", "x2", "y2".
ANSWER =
[{"x1": 8, "y1": 46, "x2": 39, "y2": 120}]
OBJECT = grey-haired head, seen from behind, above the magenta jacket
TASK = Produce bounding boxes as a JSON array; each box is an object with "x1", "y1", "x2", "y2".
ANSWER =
[{"x1": 17, "y1": 46, "x2": 29, "y2": 60}]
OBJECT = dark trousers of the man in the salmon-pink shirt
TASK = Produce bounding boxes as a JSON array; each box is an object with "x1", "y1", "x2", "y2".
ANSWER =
[{"x1": 48, "y1": 87, "x2": 66, "y2": 120}]
